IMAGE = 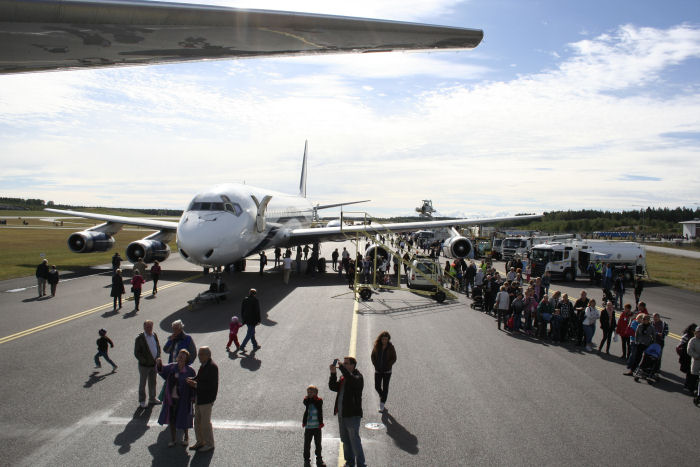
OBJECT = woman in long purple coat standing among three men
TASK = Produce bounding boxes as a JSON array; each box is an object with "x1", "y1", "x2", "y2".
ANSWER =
[{"x1": 157, "y1": 349, "x2": 196, "y2": 447}]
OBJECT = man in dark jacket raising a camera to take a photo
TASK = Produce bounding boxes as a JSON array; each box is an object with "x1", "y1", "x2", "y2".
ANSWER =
[{"x1": 328, "y1": 357, "x2": 365, "y2": 467}]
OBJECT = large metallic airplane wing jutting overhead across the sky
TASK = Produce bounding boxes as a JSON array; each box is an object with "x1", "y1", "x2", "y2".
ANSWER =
[{"x1": 0, "y1": 0, "x2": 483, "y2": 74}]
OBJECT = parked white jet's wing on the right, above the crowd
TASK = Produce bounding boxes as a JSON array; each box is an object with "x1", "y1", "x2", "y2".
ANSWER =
[{"x1": 288, "y1": 214, "x2": 542, "y2": 244}]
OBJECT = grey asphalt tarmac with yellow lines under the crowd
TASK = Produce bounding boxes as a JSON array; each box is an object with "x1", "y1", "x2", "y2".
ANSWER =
[{"x1": 0, "y1": 243, "x2": 700, "y2": 466}]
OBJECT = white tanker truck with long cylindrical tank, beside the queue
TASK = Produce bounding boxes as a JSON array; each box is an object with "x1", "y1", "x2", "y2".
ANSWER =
[{"x1": 530, "y1": 240, "x2": 646, "y2": 282}]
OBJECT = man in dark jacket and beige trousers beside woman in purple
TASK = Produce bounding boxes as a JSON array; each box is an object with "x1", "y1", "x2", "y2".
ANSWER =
[{"x1": 187, "y1": 346, "x2": 219, "y2": 452}]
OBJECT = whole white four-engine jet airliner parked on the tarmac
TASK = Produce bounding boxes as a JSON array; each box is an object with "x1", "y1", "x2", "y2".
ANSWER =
[{"x1": 46, "y1": 144, "x2": 540, "y2": 276}]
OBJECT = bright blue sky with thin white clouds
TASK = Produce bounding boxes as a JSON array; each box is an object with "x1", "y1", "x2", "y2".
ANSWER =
[{"x1": 0, "y1": 0, "x2": 700, "y2": 216}]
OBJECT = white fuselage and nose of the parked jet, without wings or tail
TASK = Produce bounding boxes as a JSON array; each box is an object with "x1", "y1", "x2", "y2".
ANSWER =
[{"x1": 177, "y1": 184, "x2": 313, "y2": 267}]
